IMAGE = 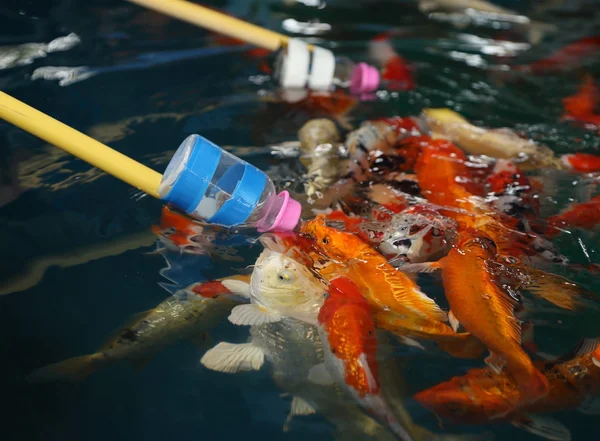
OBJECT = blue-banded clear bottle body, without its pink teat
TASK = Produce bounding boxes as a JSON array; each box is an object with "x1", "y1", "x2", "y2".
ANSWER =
[{"x1": 159, "y1": 135, "x2": 268, "y2": 227}]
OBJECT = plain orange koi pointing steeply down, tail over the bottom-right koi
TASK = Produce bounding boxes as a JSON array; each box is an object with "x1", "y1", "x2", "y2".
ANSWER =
[{"x1": 408, "y1": 230, "x2": 548, "y2": 405}]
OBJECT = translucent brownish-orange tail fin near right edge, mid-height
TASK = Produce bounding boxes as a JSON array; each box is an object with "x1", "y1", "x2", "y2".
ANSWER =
[{"x1": 520, "y1": 267, "x2": 600, "y2": 311}]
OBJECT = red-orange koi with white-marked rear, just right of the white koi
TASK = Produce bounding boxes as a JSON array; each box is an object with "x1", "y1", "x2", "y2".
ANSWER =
[{"x1": 316, "y1": 277, "x2": 412, "y2": 441}]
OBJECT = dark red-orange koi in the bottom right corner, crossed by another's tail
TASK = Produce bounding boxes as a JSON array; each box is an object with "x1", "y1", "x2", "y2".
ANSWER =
[{"x1": 414, "y1": 340, "x2": 600, "y2": 440}]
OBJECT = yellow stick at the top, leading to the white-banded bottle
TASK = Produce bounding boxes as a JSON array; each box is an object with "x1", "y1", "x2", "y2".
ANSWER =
[{"x1": 129, "y1": 0, "x2": 313, "y2": 51}]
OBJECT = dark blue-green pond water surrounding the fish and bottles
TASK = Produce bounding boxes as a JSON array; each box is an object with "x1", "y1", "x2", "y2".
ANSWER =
[{"x1": 0, "y1": 0, "x2": 600, "y2": 441}]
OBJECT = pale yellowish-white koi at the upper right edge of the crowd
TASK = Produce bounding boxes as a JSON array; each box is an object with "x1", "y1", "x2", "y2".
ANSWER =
[{"x1": 423, "y1": 109, "x2": 562, "y2": 170}]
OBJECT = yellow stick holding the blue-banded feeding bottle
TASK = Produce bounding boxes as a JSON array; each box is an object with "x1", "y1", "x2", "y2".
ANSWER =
[{"x1": 0, "y1": 92, "x2": 162, "y2": 198}]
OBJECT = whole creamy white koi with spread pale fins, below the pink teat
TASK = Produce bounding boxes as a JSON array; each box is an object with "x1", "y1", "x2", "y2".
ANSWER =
[{"x1": 201, "y1": 241, "x2": 404, "y2": 439}]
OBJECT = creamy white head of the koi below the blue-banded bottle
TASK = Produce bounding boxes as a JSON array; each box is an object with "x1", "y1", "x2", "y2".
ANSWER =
[{"x1": 250, "y1": 249, "x2": 326, "y2": 317}]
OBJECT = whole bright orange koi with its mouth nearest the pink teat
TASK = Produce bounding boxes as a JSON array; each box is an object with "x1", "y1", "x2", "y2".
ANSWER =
[{"x1": 300, "y1": 215, "x2": 488, "y2": 357}]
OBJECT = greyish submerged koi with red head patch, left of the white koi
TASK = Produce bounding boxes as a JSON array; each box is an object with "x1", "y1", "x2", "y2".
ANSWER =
[{"x1": 28, "y1": 276, "x2": 249, "y2": 382}]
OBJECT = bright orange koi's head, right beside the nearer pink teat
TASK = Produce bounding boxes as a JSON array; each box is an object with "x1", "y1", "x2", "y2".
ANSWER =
[{"x1": 300, "y1": 214, "x2": 365, "y2": 263}]
